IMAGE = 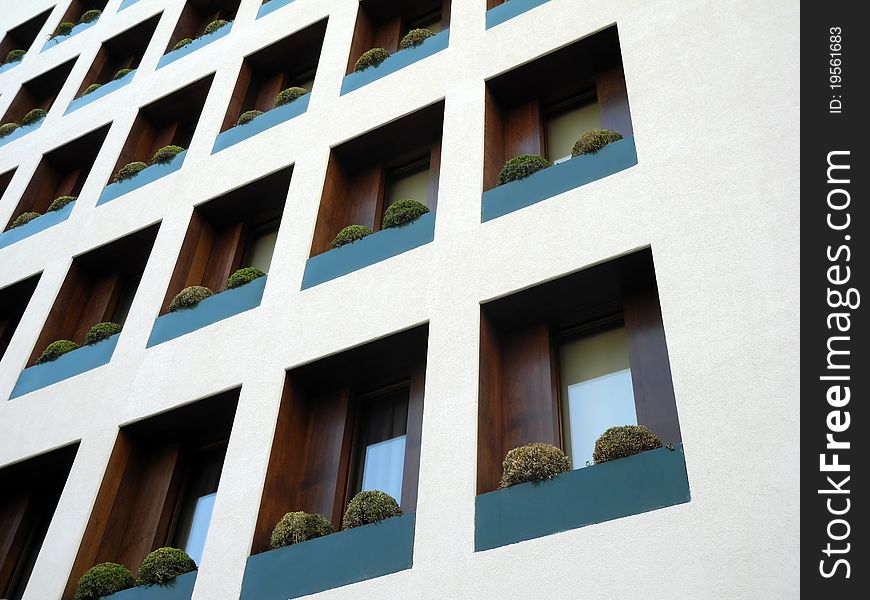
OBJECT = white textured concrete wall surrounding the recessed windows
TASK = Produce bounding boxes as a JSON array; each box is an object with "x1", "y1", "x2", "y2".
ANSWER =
[{"x1": 0, "y1": 0, "x2": 799, "y2": 600}]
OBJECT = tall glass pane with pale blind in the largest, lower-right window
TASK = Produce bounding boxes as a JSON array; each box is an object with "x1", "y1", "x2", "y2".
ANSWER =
[{"x1": 560, "y1": 326, "x2": 637, "y2": 469}]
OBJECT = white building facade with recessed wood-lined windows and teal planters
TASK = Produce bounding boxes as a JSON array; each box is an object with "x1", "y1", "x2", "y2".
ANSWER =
[{"x1": 0, "y1": 0, "x2": 799, "y2": 600}]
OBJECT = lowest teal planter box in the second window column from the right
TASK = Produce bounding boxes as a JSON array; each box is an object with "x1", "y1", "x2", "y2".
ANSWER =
[{"x1": 240, "y1": 513, "x2": 415, "y2": 600}]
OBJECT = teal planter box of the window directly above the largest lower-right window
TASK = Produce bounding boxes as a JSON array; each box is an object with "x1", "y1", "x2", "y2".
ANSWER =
[{"x1": 481, "y1": 137, "x2": 637, "y2": 223}]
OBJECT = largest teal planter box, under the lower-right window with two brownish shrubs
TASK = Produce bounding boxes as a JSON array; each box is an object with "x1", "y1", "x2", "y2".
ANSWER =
[{"x1": 474, "y1": 444, "x2": 690, "y2": 552}]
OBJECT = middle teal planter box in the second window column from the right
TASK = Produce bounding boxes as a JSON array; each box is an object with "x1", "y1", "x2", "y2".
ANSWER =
[{"x1": 302, "y1": 212, "x2": 435, "y2": 290}]
